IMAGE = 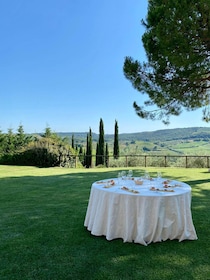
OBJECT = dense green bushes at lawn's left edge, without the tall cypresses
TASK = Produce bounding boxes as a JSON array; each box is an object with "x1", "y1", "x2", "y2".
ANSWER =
[{"x1": 0, "y1": 126, "x2": 76, "y2": 167}]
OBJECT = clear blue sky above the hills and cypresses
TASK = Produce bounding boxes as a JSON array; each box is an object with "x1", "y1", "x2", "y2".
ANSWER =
[{"x1": 0, "y1": 0, "x2": 209, "y2": 134}]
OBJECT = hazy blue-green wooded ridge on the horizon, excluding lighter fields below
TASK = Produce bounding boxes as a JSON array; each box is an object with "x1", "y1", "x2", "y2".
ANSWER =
[{"x1": 57, "y1": 127, "x2": 210, "y2": 142}]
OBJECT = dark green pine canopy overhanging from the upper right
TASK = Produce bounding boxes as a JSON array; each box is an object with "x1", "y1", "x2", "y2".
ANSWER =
[{"x1": 123, "y1": 0, "x2": 210, "y2": 124}]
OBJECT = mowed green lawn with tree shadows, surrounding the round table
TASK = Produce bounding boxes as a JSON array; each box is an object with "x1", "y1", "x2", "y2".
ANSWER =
[{"x1": 0, "y1": 166, "x2": 210, "y2": 280}]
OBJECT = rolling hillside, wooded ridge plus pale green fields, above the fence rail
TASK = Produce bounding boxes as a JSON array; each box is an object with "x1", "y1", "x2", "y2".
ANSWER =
[{"x1": 58, "y1": 127, "x2": 210, "y2": 155}]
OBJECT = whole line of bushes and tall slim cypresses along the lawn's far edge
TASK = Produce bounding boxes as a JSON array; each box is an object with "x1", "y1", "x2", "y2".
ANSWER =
[{"x1": 0, "y1": 119, "x2": 119, "y2": 168}]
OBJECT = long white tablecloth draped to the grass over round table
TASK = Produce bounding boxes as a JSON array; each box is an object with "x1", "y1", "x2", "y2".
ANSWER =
[{"x1": 84, "y1": 179, "x2": 197, "y2": 245}]
